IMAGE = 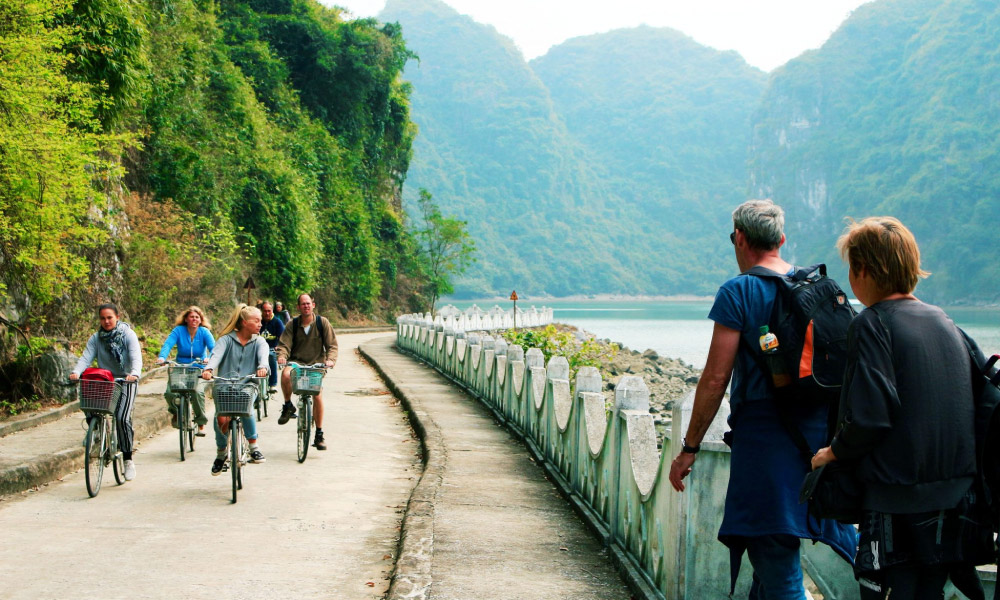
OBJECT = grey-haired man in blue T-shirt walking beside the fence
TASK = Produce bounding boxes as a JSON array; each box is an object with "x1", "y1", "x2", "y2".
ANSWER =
[{"x1": 670, "y1": 200, "x2": 856, "y2": 600}]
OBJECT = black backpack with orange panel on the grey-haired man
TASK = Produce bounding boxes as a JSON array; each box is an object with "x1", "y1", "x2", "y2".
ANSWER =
[{"x1": 741, "y1": 263, "x2": 857, "y2": 460}]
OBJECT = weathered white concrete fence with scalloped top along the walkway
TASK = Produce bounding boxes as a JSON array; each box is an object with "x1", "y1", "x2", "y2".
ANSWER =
[{"x1": 396, "y1": 311, "x2": 880, "y2": 600}]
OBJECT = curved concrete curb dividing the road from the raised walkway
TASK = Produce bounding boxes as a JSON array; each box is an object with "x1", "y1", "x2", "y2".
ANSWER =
[{"x1": 358, "y1": 342, "x2": 440, "y2": 600}]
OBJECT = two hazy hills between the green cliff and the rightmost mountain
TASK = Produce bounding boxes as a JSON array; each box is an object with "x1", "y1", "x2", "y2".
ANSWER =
[{"x1": 379, "y1": 0, "x2": 764, "y2": 296}]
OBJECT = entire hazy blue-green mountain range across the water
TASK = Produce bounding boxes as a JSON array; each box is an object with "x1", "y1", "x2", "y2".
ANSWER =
[{"x1": 380, "y1": 0, "x2": 1000, "y2": 304}]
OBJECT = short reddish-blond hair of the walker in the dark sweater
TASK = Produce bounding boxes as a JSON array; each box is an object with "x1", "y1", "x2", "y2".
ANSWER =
[{"x1": 837, "y1": 217, "x2": 930, "y2": 295}]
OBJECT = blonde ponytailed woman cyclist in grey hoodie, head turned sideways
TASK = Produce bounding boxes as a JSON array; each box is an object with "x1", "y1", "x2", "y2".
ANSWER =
[{"x1": 201, "y1": 304, "x2": 267, "y2": 475}]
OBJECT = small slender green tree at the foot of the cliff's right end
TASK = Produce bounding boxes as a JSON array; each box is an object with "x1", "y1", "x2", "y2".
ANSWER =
[{"x1": 416, "y1": 188, "x2": 476, "y2": 312}]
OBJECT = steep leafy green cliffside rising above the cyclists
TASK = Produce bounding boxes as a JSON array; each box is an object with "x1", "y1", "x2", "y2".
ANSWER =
[{"x1": 0, "y1": 0, "x2": 427, "y2": 338}]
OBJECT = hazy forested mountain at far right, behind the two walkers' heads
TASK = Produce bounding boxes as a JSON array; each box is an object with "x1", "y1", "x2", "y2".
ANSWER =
[{"x1": 750, "y1": 0, "x2": 1000, "y2": 303}]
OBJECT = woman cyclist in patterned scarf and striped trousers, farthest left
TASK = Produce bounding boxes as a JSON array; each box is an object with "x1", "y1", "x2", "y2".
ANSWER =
[{"x1": 69, "y1": 303, "x2": 142, "y2": 481}]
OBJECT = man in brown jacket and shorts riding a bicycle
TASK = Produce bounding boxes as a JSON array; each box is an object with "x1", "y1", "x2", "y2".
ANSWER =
[{"x1": 276, "y1": 294, "x2": 337, "y2": 450}]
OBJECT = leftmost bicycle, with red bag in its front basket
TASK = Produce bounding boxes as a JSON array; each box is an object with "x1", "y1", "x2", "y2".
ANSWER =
[{"x1": 78, "y1": 379, "x2": 137, "y2": 498}]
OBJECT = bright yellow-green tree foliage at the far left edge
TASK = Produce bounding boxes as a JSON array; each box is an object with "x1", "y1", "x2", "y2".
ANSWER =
[{"x1": 0, "y1": 0, "x2": 126, "y2": 305}]
